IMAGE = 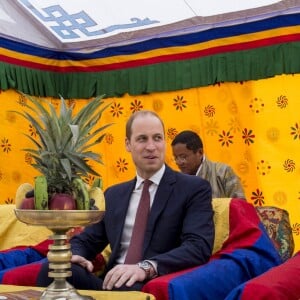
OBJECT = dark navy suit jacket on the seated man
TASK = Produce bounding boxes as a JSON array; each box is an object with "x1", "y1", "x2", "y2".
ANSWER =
[{"x1": 71, "y1": 167, "x2": 214, "y2": 275}]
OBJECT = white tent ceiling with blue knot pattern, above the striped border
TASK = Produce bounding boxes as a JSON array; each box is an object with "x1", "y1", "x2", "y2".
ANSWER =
[{"x1": 0, "y1": 0, "x2": 292, "y2": 51}]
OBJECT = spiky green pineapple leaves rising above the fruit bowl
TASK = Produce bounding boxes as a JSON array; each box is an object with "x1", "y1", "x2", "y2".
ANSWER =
[{"x1": 11, "y1": 94, "x2": 112, "y2": 197}]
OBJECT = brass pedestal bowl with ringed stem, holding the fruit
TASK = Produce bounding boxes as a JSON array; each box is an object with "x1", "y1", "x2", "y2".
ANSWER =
[{"x1": 15, "y1": 209, "x2": 104, "y2": 300}]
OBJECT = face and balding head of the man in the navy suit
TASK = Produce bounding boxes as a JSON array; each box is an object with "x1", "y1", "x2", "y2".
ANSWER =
[{"x1": 125, "y1": 115, "x2": 166, "y2": 178}]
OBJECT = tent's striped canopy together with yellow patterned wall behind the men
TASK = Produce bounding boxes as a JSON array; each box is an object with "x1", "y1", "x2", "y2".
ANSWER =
[{"x1": 0, "y1": 0, "x2": 300, "y2": 251}]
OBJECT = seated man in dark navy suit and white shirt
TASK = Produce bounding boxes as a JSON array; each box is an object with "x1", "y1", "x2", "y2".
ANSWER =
[{"x1": 38, "y1": 111, "x2": 214, "y2": 290}]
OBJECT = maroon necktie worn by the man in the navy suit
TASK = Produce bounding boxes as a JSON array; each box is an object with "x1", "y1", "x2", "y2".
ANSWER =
[{"x1": 125, "y1": 179, "x2": 152, "y2": 264}]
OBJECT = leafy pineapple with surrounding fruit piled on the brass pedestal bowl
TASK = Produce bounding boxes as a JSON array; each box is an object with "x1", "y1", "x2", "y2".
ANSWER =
[{"x1": 16, "y1": 95, "x2": 111, "y2": 210}]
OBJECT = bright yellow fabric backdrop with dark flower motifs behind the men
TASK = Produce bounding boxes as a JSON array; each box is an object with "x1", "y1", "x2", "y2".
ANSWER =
[{"x1": 0, "y1": 75, "x2": 300, "y2": 251}]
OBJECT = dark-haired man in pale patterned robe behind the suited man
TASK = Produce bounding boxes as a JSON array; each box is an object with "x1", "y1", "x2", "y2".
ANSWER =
[{"x1": 171, "y1": 130, "x2": 246, "y2": 199}]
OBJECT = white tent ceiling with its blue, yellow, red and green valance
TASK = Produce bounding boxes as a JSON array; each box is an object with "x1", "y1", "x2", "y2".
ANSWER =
[{"x1": 0, "y1": 0, "x2": 300, "y2": 98}]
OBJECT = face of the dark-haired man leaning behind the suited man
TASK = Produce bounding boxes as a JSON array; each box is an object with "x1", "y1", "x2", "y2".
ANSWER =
[{"x1": 172, "y1": 143, "x2": 203, "y2": 175}]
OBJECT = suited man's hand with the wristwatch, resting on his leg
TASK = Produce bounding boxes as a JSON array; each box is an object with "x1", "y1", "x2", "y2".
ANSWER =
[{"x1": 102, "y1": 264, "x2": 146, "y2": 290}]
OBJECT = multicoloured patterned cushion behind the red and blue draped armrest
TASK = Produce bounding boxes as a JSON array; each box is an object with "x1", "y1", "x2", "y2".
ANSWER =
[{"x1": 256, "y1": 206, "x2": 295, "y2": 261}]
